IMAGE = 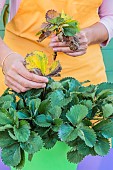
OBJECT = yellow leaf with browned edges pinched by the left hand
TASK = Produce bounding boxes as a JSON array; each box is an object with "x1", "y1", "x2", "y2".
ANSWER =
[{"x1": 25, "y1": 51, "x2": 62, "y2": 76}]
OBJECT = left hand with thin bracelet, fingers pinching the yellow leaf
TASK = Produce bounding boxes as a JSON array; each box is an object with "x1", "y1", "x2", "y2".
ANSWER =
[{"x1": 3, "y1": 53, "x2": 48, "y2": 93}]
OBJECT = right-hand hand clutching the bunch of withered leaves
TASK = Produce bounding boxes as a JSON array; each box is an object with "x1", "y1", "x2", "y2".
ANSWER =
[{"x1": 50, "y1": 31, "x2": 88, "y2": 57}]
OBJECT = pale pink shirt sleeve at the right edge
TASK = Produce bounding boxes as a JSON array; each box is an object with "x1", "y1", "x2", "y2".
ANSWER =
[{"x1": 98, "y1": 0, "x2": 113, "y2": 46}]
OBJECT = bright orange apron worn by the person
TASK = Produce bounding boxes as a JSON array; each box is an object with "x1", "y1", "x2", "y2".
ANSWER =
[{"x1": 0, "y1": 0, "x2": 106, "y2": 95}]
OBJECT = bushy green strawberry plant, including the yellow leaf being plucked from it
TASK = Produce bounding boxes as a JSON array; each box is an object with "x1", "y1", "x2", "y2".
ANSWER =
[{"x1": 0, "y1": 51, "x2": 113, "y2": 169}]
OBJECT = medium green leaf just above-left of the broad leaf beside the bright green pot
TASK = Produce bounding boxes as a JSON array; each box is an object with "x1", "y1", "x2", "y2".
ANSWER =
[{"x1": 14, "y1": 120, "x2": 30, "y2": 142}]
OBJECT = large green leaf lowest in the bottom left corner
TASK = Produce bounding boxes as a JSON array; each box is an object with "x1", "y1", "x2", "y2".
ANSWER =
[{"x1": 1, "y1": 143, "x2": 21, "y2": 166}]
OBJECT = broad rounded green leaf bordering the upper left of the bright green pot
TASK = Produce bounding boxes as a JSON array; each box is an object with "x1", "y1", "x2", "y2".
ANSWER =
[{"x1": 20, "y1": 132, "x2": 43, "y2": 154}]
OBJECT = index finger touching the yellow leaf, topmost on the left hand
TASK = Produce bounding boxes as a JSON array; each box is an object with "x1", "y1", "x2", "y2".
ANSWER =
[{"x1": 10, "y1": 62, "x2": 48, "y2": 83}]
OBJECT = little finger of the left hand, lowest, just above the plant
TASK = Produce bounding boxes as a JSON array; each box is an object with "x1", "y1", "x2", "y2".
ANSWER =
[{"x1": 6, "y1": 77, "x2": 30, "y2": 92}]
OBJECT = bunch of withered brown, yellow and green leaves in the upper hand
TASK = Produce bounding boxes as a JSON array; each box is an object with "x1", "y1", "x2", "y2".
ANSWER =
[{"x1": 36, "y1": 10, "x2": 79, "y2": 60}]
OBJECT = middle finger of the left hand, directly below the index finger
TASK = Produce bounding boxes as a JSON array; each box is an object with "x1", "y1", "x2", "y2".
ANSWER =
[{"x1": 7, "y1": 72, "x2": 46, "y2": 88}]
